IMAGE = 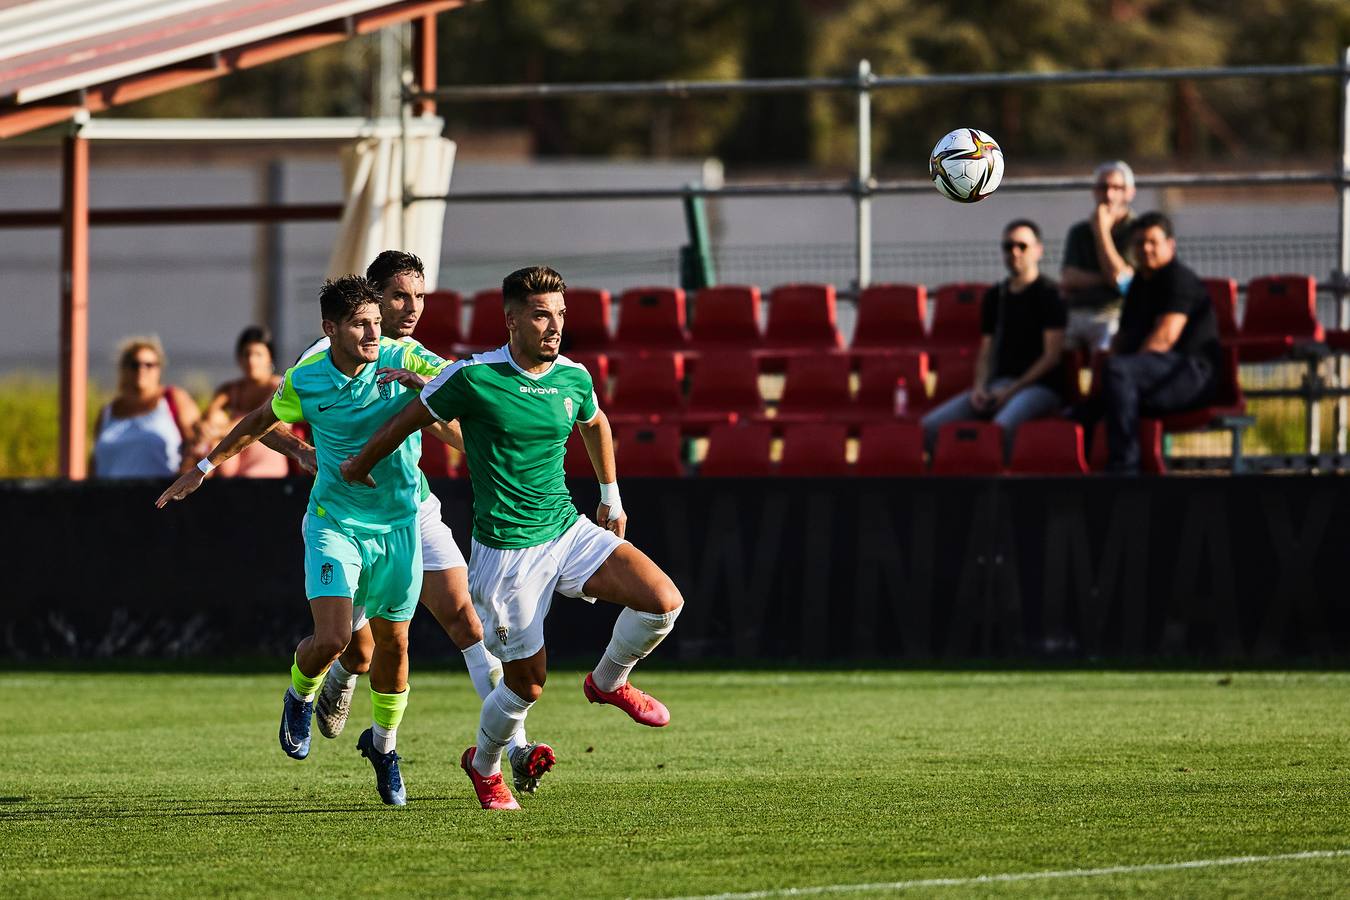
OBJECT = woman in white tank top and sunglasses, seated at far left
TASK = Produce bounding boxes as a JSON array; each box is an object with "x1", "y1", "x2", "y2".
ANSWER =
[{"x1": 93, "y1": 337, "x2": 201, "y2": 478}]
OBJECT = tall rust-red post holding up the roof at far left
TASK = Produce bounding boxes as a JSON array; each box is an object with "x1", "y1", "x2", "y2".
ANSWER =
[{"x1": 61, "y1": 117, "x2": 89, "y2": 482}]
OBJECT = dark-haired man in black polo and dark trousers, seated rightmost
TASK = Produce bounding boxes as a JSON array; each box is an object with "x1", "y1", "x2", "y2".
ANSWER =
[{"x1": 1089, "y1": 212, "x2": 1220, "y2": 474}]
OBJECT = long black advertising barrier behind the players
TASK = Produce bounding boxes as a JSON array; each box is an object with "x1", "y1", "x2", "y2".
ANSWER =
[{"x1": 0, "y1": 476, "x2": 1350, "y2": 660}]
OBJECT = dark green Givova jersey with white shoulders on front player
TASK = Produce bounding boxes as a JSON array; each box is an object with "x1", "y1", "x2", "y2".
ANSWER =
[{"x1": 421, "y1": 347, "x2": 599, "y2": 549}]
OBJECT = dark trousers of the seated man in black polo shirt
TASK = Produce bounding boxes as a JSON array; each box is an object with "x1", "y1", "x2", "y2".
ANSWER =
[{"x1": 1094, "y1": 352, "x2": 1214, "y2": 475}]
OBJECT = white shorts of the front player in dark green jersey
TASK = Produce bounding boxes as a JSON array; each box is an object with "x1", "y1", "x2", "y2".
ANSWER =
[{"x1": 468, "y1": 515, "x2": 626, "y2": 661}]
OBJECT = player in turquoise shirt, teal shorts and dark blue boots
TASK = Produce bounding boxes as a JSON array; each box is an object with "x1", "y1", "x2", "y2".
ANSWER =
[{"x1": 157, "y1": 275, "x2": 444, "y2": 806}]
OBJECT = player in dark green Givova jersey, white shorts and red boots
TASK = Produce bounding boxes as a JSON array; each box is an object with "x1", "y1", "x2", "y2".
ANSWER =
[{"x1": 342, "y1": 267, "x2": 684, "y2": 810}]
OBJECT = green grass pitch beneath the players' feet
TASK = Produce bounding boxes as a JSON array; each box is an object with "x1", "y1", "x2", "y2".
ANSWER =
[{"x1": 0, "y1": 664, "x2": 1350, "y2": 897}]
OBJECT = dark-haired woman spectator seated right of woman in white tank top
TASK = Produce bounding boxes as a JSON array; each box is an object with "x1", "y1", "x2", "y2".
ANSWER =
[{"x1": 196, "y1": 325, "x2": 288, "y2": 478}]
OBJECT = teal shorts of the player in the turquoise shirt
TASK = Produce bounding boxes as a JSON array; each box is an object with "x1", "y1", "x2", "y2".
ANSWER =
[{"x1": 304, "y1": 513, "x2": 421, "y2": 622}]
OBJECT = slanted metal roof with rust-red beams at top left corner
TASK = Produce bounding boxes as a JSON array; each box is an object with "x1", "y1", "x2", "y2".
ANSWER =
[{"x1": 0, "y1": 0, "x2": 470, "y2": 139}]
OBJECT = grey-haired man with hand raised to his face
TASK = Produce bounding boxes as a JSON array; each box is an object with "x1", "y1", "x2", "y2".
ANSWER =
[{"x1": 1060, "y1": 159, "x2": 1134, "y2": 352}]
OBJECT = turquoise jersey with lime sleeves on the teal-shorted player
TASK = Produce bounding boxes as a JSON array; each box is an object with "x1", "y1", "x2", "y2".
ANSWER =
[{"x1": 271, "y1": 337, "x2": 446, "y2": 532}]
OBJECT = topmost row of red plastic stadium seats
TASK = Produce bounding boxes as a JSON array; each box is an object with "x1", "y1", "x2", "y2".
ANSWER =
[{"x1": 417, "y1": 275, "x2": 1323, "y2": 367}]
